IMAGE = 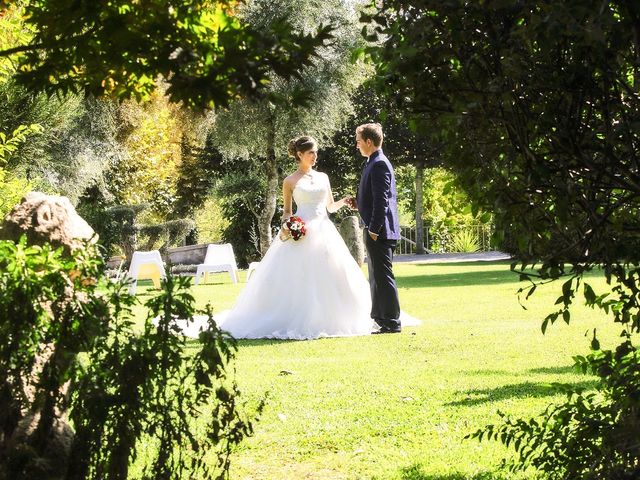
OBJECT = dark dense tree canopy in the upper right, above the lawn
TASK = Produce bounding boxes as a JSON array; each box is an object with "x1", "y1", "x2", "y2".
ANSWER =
[{"x1": 372, "y1": 0, "x2": 640, "y2": 263}]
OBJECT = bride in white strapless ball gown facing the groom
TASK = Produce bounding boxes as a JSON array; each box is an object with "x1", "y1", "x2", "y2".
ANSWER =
[{"x1": 216, "y1": 136, "x2": 416, "y2": 340}]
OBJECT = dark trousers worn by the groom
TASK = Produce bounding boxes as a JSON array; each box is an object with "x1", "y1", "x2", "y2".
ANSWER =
[{"x1": 364, "y1": 228, "x2": 400, "y2": 329}]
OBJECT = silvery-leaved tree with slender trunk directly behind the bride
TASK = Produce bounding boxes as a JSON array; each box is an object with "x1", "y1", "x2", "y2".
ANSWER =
[{"x1": 211, "y1": 0, "x2": 367, "y2": 254}]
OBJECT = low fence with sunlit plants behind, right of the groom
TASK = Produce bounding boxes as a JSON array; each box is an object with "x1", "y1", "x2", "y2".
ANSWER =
[{"x1": 396, "y1": 224, "x2": 495, "y2": 254}]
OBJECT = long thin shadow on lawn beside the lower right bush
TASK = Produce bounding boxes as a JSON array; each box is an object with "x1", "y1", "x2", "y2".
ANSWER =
[{"x1": 446, "y1": 379, "x2": 598, "y2": 406}]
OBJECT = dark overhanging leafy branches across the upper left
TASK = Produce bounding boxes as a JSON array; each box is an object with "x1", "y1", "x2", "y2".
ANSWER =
[{"x1": 0, "y1": 0, "x2": 331, "y2": 109}]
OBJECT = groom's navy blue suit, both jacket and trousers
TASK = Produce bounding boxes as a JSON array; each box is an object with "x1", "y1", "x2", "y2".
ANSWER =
[{"x1": 357, "y1": 150, "x2": 400, "y2": 329}]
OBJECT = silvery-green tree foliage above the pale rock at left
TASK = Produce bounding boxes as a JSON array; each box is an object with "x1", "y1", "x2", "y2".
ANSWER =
[{"x1": 0, "y1": 78, "x2": 123, "y2": 203}]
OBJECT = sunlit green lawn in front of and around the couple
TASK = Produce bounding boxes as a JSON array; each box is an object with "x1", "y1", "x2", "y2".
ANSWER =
[{"x1": 136, "y1": 262, "x2": 619, "y2": 480}]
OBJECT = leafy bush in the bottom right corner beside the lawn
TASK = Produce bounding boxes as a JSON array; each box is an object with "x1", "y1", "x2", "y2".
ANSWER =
[{"x1": 467, "y1": 340, "x2": 640, "y2": 480}]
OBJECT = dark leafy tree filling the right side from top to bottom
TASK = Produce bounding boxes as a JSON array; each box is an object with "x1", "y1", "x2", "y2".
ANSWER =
[{"x1": 369, "y1": 0, "x2": 640, "y2": 478}]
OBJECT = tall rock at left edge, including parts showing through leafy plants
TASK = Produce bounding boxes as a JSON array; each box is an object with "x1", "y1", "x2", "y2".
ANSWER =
[{"x1": 0, "y1": 192, "x2": 97, "y2": 480}]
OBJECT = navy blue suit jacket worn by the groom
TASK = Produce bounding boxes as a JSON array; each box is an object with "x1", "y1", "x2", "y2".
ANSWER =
[{"x1": 356, "y1": 150, "x2": 400, "y2": 240}]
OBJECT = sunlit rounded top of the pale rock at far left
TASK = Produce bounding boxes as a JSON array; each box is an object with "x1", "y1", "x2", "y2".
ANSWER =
[{"x1": 0, "y1": 192, "x2": 97, "y2": 251}]
